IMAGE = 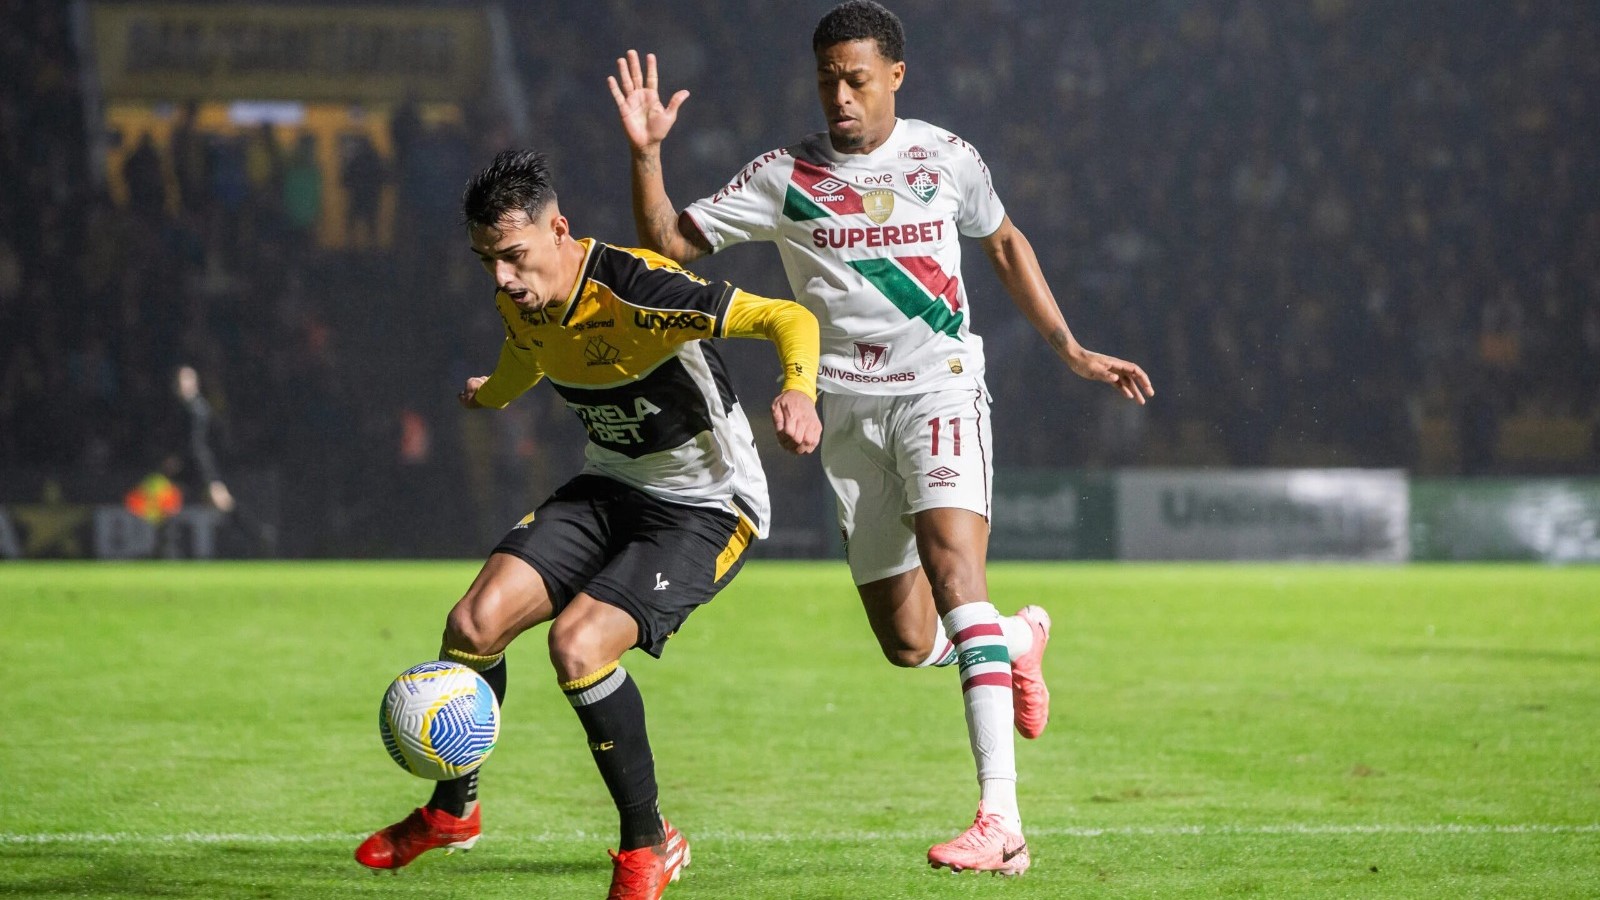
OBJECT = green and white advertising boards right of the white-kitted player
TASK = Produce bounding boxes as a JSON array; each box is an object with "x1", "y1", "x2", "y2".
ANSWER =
[{"x1": 989, "y1": 469, "x2": 1600, "y2": 564}]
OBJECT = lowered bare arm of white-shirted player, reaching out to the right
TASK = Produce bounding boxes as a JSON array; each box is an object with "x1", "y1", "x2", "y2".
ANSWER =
[{"x1": 981, "y1": 216, "x2": 1155, "y2": 404}]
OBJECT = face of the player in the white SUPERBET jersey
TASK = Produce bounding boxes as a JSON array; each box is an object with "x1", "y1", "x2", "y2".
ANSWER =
[{"x1": 816, "y1": 40, "x2": 906, "y2": 154}]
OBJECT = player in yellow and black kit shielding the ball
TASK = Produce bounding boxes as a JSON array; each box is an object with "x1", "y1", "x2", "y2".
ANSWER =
[{"x1": 355, "y1": 151, "x2": 822, "y2": 900}]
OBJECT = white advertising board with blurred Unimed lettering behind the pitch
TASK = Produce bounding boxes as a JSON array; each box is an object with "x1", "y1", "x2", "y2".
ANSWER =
[{"x1": 1117, "y1": 469, "x2": 1411, "y2": 562}]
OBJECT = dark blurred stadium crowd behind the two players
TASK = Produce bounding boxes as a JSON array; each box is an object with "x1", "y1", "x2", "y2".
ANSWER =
[{"x1": 0, "y1": 0, "x2": 1600, "y2": 552}]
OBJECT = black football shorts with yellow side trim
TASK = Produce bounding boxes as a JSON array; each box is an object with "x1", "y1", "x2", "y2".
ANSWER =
[{"x1": 494, "y1": 476, "x2": 754, "y2": 657}]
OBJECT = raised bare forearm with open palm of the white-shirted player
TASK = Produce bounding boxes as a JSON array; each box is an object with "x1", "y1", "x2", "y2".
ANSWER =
[{"x1": 606, "y1": 50, "x2": 710, "y2": 263}]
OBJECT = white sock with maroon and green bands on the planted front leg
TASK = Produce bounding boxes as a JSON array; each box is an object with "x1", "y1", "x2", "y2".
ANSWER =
[{"x1": 944, "y1": 602, "x2": 1021, "y2": 828}]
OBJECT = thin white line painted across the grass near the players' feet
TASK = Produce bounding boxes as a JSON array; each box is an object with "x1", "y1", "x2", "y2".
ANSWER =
[{"x1": 0, "y1": 823, "x2": 1600, "y2": 846}]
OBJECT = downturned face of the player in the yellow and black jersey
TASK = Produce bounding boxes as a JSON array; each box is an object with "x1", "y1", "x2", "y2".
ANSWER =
[{"x1": 467, "y1": 203, "x2": 582, "y2": 311}]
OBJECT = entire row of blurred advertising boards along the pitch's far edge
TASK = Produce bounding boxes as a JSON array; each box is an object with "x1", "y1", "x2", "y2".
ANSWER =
[{"x1": 0, "y1": 469, "x2": 1600, "y2": 564}]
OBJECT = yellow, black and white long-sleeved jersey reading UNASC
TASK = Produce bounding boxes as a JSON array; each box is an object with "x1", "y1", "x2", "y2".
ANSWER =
[{"x1": 477, "y1": 239, "x2": 818, "y2": 536}]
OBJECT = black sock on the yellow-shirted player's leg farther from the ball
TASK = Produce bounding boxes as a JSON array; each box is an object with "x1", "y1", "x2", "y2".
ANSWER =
[{"x1": 562, "y1": 666, "x2": 667, "y2": 850}]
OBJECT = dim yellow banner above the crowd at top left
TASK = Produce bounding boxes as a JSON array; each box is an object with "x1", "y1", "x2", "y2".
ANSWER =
[{"x1": 91, "y1": 3, "x2": 490, "y2": 101}]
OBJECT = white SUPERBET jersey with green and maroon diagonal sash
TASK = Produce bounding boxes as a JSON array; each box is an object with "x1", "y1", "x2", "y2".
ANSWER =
[{"x1": 685, "y1": 119, "x2": 1005, "y2": 394}]
